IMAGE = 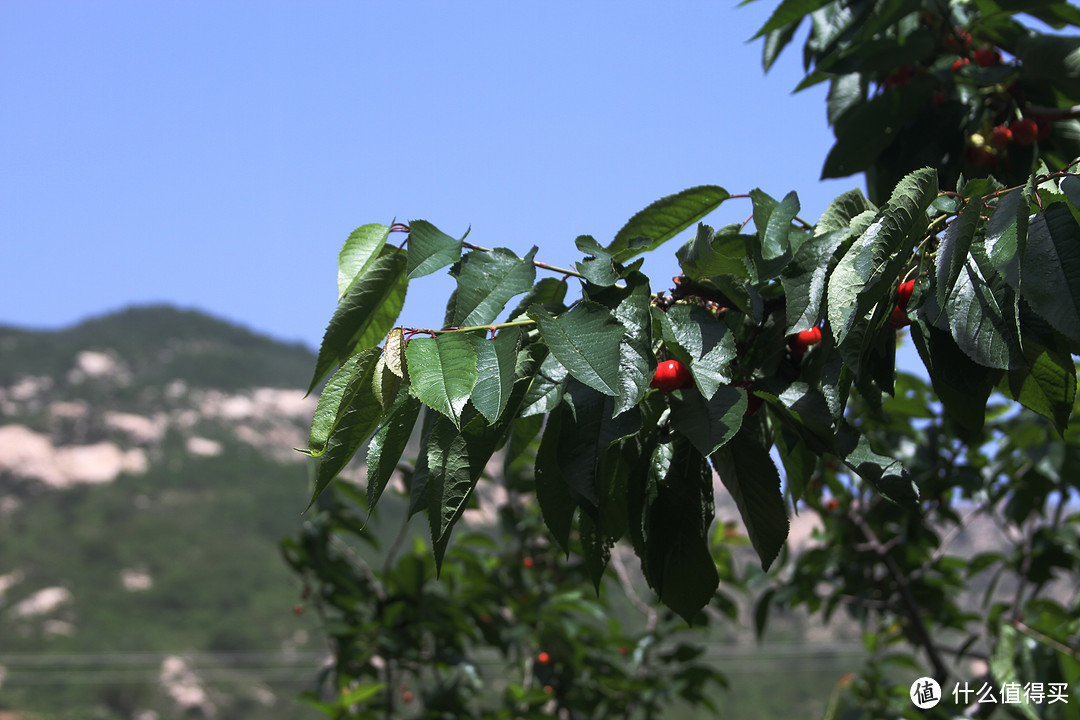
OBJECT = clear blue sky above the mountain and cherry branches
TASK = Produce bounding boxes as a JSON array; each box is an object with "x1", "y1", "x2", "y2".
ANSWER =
[{"x1": 0, "y1": 0, "x2": 863, "y2": 348}]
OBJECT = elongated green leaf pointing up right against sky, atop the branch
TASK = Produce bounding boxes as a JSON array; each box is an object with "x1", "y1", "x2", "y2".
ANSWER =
[{"x1": 607, "y1": 185, "x2": 730, "y2": 262}]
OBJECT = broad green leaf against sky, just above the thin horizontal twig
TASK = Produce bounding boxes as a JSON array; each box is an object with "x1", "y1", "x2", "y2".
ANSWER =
[{"x1": 449, "y1": 247, "x2": 537, "y2": 327}]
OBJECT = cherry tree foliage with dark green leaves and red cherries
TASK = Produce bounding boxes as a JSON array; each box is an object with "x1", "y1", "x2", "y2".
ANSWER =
[{"x1": 285, "y1": 0, "x2": 1080, "y2": 718}]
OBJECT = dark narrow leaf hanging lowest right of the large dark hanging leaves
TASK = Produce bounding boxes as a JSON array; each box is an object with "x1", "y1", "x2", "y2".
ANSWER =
[{"x1": 710, "y1": 431, "x2": 789, "y2": 570}]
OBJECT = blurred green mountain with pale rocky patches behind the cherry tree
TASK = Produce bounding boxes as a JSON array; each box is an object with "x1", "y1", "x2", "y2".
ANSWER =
[{"x1": 0, "y1": 307, "x2": 325, "y2": 720}]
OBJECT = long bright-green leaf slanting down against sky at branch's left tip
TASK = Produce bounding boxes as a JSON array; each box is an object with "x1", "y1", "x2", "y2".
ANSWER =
[{"x1": 308, "y1": 248, "x2": 408, "y2": 393}]
